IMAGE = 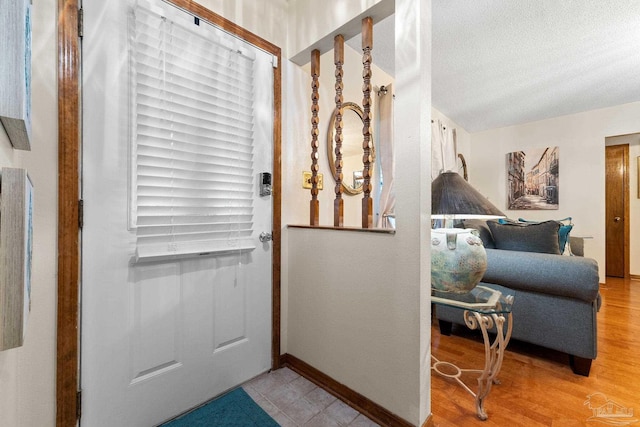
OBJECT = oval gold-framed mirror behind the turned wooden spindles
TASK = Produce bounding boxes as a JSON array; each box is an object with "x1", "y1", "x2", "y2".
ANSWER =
[{"x1": 327, "y1": 102, "x2": 375, "y2": 194}]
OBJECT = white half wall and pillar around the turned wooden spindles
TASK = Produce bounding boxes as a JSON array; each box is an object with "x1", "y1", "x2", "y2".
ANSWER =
[{"x1": 283, "y1": 0, "x2": 431, "y2": 424}]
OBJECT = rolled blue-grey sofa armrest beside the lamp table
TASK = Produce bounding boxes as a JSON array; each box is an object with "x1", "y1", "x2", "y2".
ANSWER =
[{"x1": 482, "y1": 249, "x2": 600, "y2": 303}]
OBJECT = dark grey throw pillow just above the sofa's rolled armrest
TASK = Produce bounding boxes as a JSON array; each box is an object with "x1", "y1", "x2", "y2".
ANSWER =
[{"x1": 487, "y1": 221, "x2": 560, "y2": 254}]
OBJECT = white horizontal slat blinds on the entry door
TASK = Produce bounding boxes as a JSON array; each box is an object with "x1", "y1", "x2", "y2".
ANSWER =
[{"x1": 131, "y1": 6, "x2": 255, "y2": 260}]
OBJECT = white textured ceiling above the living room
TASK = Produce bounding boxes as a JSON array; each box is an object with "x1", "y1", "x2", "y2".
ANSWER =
[{"x1": 348, "y1": 0, "x2": 640, "y2": 132}]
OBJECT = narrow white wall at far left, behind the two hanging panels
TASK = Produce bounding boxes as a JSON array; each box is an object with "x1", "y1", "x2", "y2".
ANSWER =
[{"x1": 0, "y1": 0, "x2": 58, "y2": 427}]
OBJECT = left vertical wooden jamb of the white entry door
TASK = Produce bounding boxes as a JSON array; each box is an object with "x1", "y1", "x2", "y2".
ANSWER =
[{"x1": 56, "y1": 0, "x2": 80, "y2": 427}]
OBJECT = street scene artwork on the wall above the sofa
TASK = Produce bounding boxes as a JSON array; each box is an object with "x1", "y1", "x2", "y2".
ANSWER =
[{"x1": 507, "y1": 147, "x2": 560, "y2": 210}]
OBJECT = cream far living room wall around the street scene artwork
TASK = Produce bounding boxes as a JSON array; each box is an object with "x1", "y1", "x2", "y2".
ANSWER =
[{"x1": 468, "y1": 102, "x2": 640, "y2": 282}]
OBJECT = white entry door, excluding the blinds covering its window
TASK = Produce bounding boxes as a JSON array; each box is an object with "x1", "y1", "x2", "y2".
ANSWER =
[{"x1": 80, "y1": 0, "x2": 273, "y2": 427}]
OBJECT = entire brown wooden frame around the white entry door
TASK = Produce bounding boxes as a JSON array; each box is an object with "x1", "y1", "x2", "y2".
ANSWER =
[{"x1": 56, "y1": 0, "x2": 282, "y2": 427}]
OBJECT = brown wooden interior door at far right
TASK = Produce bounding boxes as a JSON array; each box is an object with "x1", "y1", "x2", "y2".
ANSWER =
[{"x1": 605, "y1": 144, "x2": 629, "y2": 277}]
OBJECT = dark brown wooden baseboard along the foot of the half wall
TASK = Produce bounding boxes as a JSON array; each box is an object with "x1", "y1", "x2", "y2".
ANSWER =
[{"x1": 280, "y1": 354, "x2": 412, "y2": 427}]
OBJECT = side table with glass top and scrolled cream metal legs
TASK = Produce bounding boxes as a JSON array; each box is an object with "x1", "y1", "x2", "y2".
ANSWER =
[{"x1": 431, "y1": 285, "x2": 514, "y2": 420}]
